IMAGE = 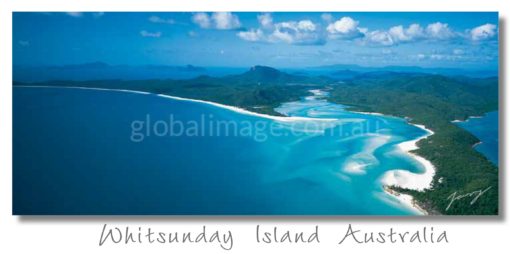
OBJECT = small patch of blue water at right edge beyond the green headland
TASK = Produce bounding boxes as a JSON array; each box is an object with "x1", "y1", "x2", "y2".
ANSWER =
[{"x1": 457, "y1": 111, "x2": 499, "y2": 166}]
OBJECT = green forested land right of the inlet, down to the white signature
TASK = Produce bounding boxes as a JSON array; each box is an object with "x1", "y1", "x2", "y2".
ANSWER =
[{"x1": 330, "y1": 75, "x2": 498, "y2": 215}]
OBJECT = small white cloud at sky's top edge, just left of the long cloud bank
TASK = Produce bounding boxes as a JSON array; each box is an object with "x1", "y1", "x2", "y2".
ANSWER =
[{"x1": 191, "y1": 12, "x2": 241, "y2": 30}]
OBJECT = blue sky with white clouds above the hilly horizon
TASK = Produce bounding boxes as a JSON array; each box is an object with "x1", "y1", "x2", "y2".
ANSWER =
[{"x1": 13, "y1": 12, "x2": 499, "y2": 69}]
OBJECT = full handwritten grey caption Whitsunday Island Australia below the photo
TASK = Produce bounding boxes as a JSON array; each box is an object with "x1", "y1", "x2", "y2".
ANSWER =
[{"x1": 99, "y1": 224, "x2": 449, "y2": 251}]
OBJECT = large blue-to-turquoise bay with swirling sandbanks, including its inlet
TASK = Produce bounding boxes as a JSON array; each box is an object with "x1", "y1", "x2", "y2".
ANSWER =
[{"x1": 13, "y1": 87, "x2": 426, "y2": 215}]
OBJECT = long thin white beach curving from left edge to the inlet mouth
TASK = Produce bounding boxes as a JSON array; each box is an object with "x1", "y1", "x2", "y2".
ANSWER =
[{"x1": 13, "y1": 85, "x2": 337, "y2": 122}]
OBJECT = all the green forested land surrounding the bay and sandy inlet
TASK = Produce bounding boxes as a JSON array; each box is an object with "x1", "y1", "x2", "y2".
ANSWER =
[{"x1": 14, "y1": 66, "x2": 498, "y2": 215}]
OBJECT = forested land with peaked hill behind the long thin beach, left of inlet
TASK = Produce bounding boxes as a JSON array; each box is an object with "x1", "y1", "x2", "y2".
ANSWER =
[{"x1": 14, "y1": 66, "x2": 333, "y2": 115}]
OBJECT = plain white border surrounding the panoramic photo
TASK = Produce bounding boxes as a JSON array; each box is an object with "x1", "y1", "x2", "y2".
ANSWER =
[{"x1": 0, "y1": 0, "x2": 510, "y2": 254}]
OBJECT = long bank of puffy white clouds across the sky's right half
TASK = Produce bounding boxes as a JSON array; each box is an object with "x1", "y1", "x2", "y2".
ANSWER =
[{"x1": 237, "y1": 13, "x2": 497, "y2": 48}]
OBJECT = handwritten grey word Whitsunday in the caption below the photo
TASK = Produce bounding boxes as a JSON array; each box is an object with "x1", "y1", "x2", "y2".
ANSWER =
[{"x1": 99, "y1": 224, "x2": 234, "y2": 250}]
